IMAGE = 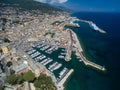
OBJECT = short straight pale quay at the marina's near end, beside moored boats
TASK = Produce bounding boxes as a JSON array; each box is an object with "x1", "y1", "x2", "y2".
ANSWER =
[{"x1": 58, "y1": 69, "x2": 74, "y2": 90}]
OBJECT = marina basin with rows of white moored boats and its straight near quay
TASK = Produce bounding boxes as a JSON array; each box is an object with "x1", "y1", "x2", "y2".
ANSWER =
[{"x1": 26, "y1": 43, "x2": 74, "y2": 90}]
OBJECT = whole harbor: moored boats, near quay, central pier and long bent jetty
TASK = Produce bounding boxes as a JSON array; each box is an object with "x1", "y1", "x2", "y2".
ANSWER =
[{"x1": 22, "y1": 16, "x2": 106, "y2": 90}]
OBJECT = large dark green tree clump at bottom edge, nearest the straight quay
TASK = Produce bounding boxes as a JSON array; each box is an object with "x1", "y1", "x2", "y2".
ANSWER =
[{"x1": 34, "y1": 74, "x2": 57, "y2": 90}]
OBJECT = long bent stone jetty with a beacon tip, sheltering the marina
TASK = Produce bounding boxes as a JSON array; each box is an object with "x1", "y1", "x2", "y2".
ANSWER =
[{"x1": 71, "y1": 30, "x2": 106, "y2": 71}]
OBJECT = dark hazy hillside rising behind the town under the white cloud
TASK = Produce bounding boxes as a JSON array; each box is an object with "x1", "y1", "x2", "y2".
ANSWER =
[{"x1": 0, "y1": 0, "x2": 63, "y2": 14}]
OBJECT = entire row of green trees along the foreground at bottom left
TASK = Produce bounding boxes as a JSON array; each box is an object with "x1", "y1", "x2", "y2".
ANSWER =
[{"x1": 6, "y1": 71, "x2": 57, "y2": 90}]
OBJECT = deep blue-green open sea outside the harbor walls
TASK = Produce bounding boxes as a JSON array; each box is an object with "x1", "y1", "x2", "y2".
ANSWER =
[{"x1": 65, "y1": 12, "x2": 120, "y2": 90}]
